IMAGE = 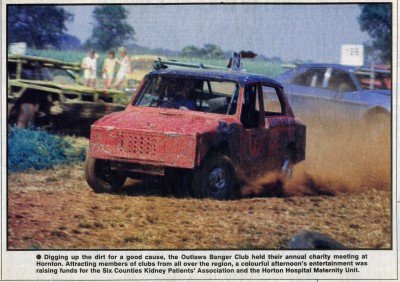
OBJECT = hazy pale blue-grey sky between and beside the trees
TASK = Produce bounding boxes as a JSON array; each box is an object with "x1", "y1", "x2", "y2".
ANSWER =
[{"x1": 63, "y1": 4, "x2": 370, "y2": 63}]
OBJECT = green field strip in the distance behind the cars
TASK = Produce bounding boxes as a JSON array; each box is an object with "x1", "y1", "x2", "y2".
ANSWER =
[{"x1": 21, "y1": 49, "x2": 284, "y2": 77}]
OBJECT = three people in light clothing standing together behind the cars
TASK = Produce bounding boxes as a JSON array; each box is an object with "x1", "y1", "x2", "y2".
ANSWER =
[{"x1": 81, "y1": 47, "x2": 132, "y2": 90}]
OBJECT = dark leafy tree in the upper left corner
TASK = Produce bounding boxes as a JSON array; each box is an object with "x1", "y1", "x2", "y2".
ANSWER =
[{"x1": 7, "y1": 5, "x2": 74, "y2": 49}]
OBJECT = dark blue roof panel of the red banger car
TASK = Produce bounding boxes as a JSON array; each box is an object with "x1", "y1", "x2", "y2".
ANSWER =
[{"x1": 148, "y1": 68, "x2": 282, "y2": 87}]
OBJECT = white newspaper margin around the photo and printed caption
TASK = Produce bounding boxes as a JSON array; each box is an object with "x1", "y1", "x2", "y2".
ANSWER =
[{"x1": 0, "y1": 0, "x2": 400, "y2": 281}]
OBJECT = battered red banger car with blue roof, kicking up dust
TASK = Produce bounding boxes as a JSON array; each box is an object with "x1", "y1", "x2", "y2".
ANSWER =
[{"x1": 85, "y1": 68, "x2": 306, "y2": 199}]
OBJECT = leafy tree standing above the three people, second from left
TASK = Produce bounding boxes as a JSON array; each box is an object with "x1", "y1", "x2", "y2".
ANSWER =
[{"x1": 86, "y1": 5, "x2": 135, "y2": 51}]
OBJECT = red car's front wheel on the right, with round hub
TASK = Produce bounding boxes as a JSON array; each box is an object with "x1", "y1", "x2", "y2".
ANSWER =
[{"x1": 192, "y1": 154, "x2": 235, "y2": 200}]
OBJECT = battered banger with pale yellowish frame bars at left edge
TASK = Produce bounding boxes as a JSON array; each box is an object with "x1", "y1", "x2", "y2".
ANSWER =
[{"x1": 7, "y1": 55, "x2": 128, "y2": 133}]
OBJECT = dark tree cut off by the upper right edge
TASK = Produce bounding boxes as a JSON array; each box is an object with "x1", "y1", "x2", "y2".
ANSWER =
[{"x1": 358, "y1": 4, "x2": 392, "y2": 63}]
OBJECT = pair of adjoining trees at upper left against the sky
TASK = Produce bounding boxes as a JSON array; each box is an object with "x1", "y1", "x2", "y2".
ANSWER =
[{"x1": 7, "y1": 5, "x2": 135, "y2": 51}]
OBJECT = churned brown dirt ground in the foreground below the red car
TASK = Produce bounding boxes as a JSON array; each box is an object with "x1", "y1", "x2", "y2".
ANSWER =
[{"x1": 8, "y1": 165, "x2": 391, "y2": 249}]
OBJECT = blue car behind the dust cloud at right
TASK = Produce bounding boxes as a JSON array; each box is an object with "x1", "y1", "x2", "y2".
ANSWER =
[{"x1": 274, "y1": 64, "x2": 391, "y2": 126}]
